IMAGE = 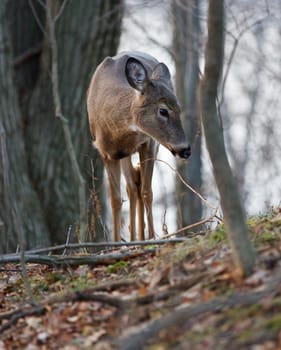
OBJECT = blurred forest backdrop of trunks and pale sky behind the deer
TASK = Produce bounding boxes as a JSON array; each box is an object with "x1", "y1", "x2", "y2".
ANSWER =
[{"x1": 0, "y1": 0, "x2": 281, "y2": 253}]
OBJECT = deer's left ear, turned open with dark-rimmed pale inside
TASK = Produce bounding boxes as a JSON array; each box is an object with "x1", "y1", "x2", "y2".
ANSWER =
[{"x1": 126, "y1": 57, "x2": 147, "y2": 92}]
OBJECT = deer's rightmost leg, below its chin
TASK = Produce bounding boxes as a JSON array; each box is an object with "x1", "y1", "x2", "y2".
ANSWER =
[{"x1": 139, "y1": 140, "x2": 158, "y2": 239}]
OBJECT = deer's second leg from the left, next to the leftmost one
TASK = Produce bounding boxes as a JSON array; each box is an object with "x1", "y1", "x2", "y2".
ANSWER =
[{"x1": 121, "y1": 157, "x2": 143, "y2": 241}]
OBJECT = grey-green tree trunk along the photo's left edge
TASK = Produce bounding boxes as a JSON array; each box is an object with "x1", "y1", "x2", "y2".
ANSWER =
[{"x1": 0, "y1": 0, "x2": 49, "y2": 253}]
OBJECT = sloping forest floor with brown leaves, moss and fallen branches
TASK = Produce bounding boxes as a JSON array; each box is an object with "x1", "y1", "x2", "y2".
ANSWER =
[{"x1": 0, "y1": 209, "x2": 281, "y2": 350}]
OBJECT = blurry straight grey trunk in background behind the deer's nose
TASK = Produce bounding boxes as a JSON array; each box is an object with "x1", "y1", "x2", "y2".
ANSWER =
[{"x1": 173, "y1": 0, "x2": 202, "y2": 227}]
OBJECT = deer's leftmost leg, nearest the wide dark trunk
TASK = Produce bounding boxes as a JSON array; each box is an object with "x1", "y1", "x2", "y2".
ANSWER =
[{"x1": 104, "y1": 159, "x2": 122, "y2": 242}]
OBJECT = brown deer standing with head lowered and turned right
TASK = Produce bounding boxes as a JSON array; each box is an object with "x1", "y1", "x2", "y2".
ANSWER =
[{"x1": 87, "y1": 52, "x2": 191, "y2": 242}]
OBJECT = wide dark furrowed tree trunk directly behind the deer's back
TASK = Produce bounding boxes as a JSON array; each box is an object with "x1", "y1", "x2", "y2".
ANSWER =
[{"x1": 26, "y1": 0, "x2": 122, "y2": 246}]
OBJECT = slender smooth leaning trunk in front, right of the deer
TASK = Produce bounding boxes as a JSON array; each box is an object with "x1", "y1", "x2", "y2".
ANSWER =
[{"x1": 200, "y1": 0, "x2": 255, "y2": 275}]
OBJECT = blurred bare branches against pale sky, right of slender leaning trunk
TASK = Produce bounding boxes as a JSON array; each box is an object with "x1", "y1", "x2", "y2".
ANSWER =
[{"x1": 220, "y1": 0, "x2": 281, "y2": 214}]
